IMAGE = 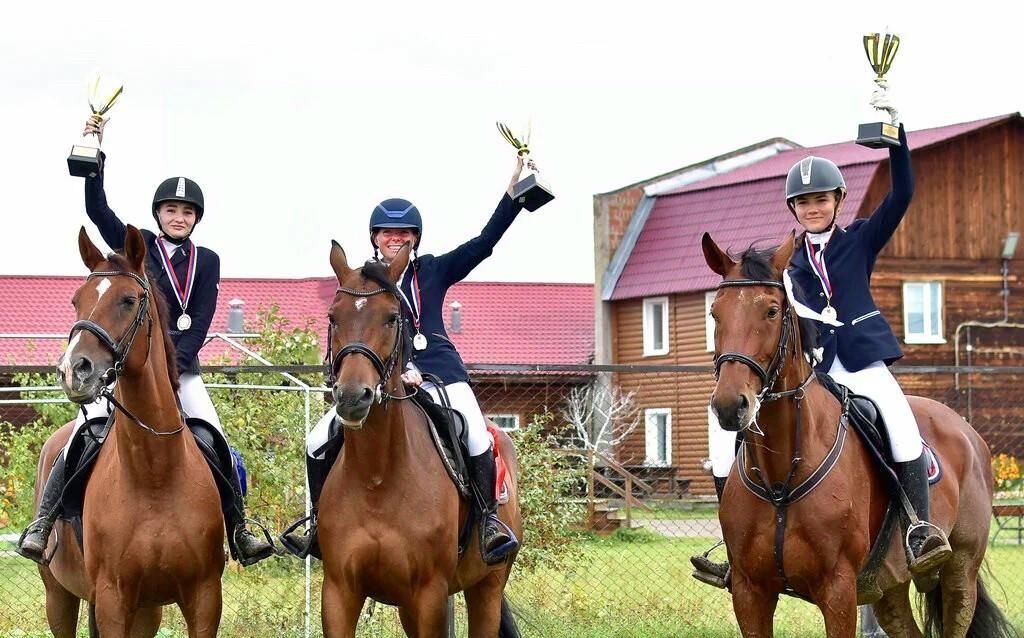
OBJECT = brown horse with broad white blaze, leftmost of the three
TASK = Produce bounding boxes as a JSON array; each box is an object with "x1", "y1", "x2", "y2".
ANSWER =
[{"x1": 36, "y1": 226, "x2": 224, "y2": 638}]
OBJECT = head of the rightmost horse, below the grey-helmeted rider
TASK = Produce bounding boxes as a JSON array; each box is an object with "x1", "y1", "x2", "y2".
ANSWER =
[{"x1": 701, "y1": 232, "x2": 800, "y2": 431}]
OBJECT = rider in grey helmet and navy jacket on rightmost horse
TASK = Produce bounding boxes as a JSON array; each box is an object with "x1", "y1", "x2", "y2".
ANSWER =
[{"x1": 690, "y1": 108, "x2": 951, "y2": 585}]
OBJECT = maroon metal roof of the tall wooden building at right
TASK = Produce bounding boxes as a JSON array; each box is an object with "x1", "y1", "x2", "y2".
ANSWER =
[{"x1": 611, "y1": 115, "x2": 1017, "y2": 300}]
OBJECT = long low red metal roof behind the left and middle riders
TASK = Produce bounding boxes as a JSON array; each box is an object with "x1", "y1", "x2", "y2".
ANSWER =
[{"x1": 0, "y1": 275, "x2": 594, "y2": 365}]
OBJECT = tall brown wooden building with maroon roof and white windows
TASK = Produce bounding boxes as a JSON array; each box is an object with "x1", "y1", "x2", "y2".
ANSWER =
[{"x1": 594, "y1": 114, "x2": 1024, "y2": 494}]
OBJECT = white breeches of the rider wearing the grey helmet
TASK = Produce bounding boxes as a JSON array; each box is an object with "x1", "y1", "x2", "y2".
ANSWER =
[{"x1": 708, "y1": 356, "x2": 924, "y2": 477}]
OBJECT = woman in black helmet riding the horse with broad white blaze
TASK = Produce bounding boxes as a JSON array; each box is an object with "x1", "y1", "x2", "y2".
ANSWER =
[{"x1": 16, "y1": 119, "x2": 273, "y2": 565}]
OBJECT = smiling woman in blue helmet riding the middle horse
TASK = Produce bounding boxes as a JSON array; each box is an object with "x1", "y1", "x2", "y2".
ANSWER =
[{"x1": 284, "y1": 158, "x2": 532, "y2": 563}]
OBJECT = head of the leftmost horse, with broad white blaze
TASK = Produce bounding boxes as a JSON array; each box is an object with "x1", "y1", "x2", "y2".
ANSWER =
[{"x1": 57, "y1": 225, "x2": 163, "y2": 403}]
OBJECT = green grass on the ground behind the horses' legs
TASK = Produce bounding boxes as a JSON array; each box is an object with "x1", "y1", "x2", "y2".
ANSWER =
[{"x1": 0, "y1": 530, "x2": 1024, "y2": 638}]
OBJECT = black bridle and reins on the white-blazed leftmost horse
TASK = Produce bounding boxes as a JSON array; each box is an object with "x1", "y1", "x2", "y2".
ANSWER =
[{"x1": 68, "y1": 270, "x2": 185, "y2": 436}]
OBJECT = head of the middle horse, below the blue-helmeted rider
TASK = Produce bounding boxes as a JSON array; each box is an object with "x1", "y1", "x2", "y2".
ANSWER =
[{"x1": 328, "y1": 242, "x2": 413, "y2": 429}]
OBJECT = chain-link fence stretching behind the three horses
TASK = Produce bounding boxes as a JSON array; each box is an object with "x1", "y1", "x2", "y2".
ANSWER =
[{"x1": 0, "y1": 366, "x2": 1024, "y2": 637}]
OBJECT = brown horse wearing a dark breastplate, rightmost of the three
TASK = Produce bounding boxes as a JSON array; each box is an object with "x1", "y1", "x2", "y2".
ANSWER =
[{"x1": 702, "y1": 233, "x2": 1015, "y2": 638}]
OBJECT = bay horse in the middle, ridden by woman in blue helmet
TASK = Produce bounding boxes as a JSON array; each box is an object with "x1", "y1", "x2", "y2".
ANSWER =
[{"x1": 318, "y1": 242, "x2": 522, "y2": 638}]
